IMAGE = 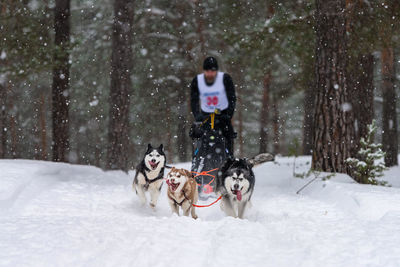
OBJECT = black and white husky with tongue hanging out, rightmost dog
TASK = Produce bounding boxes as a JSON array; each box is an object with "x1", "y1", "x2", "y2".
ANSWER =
[{"x1": 216, "y1": 158, "x2": 255, "y2": 218}]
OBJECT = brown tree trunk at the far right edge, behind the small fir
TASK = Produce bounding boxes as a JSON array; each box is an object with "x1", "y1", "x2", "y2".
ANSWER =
[{"x1": 382, "y1": 45, "x2": 398, "y2": 167}]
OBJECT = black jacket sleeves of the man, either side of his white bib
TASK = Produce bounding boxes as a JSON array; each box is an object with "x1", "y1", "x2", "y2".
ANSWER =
[{"x1": 190, "y1": 73, "x2": 236, "y2": 121}]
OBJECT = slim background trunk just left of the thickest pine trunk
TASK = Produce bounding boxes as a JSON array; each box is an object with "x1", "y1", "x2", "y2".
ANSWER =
[{"x1": 303, "y1": 77, "x2": 315, "y2": 155}]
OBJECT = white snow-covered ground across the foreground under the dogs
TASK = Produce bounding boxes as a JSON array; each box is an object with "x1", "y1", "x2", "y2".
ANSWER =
[{"x1": 0, "y1": 157, "x2": 400, "y2": 267}]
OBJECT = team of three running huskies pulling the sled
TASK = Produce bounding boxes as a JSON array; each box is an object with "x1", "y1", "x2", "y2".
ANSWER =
[{"x1": 133, "y1": 144, "x2": 255, "y2": 219}]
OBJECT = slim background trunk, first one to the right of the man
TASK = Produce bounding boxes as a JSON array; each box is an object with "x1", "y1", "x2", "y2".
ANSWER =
[{"x1": 259, "y1": 71, "x2": 271, "y2": 154}]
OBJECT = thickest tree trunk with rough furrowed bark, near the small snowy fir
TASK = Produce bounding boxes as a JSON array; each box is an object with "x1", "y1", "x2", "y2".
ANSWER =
[{"x1": 312, "y1": 0, "x2": 354, "y2": 173}]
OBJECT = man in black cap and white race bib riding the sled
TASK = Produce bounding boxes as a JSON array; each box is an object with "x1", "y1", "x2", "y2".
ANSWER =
[{"x1": 191, "y1": 57, "x2": 236, "y2": 156}]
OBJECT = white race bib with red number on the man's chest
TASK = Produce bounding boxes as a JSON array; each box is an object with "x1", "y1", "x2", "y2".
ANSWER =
[{"x1": 197, "y1": 72, "x2": 229, "y2": 113}]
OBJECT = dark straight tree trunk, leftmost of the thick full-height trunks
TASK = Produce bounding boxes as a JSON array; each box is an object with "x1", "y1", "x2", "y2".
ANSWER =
[{"x1": 52, "y1": 0, "x2": 70, "y2": 162}]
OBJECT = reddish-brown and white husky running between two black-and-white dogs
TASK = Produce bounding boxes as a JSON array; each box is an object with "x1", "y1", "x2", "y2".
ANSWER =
[{"x1": 167, "y1": 167, "x2": 199, "y2": 219}]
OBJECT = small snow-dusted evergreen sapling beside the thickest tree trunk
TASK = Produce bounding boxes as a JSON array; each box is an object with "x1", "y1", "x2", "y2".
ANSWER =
[{"x1": 346, "y1": 120, "x2": 387, "y2": 185}]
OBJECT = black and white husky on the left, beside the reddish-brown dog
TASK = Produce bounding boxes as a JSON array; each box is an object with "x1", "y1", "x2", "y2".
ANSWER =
[{"x1": 133, "y1": 144, "x2": 166, "y2": 208}]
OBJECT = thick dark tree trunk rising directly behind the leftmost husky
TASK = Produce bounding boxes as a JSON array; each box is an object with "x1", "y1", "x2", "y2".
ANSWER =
[{"x1": 106, "y1": 0, "x2": 134, "y2": 171}]
